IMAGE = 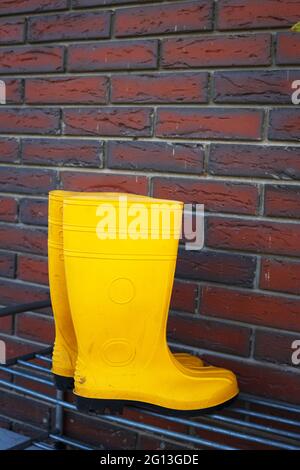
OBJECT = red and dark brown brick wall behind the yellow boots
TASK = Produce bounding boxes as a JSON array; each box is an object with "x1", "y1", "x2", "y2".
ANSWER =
[{"x1": 0, "y1": 0, "x2": 300, "y2": 446}]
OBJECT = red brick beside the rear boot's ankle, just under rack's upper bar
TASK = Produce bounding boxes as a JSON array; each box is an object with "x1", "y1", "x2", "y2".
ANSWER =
[{"x1": 16, "y1": 313, "x2": 54, "y2": 344}]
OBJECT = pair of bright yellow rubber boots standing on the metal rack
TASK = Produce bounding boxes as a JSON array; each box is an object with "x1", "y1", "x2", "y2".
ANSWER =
[{"x1": 48, "y1": 190, "x2": 238, "y2": 412}]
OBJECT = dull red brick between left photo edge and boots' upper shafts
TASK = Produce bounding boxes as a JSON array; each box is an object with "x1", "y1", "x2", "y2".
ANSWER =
[{"x1": 0, "y1": 224, "x2": 47, "y2": 255}]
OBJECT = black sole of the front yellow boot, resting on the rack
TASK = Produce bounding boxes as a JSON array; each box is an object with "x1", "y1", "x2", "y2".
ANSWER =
[{"x1": 75, "y1": 395, "x2": 238, "y2": 417}]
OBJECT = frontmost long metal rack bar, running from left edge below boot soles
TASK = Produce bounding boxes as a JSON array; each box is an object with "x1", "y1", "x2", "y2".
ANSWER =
[{"x1": 0, "y1": 379, "x2": 237, "y2": 450}]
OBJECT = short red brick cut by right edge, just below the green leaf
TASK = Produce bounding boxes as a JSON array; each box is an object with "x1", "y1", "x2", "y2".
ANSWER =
[{"x1": 276, "y1": 32, "x2": 300, "y2": 65}]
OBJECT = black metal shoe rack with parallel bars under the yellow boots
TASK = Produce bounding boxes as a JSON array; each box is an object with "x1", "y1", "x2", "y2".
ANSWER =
[{"x1": 0, "y1": 301, "x2": 300, "y2": 450}]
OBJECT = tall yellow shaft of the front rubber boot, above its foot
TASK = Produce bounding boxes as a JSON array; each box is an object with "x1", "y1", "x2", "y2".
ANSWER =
[{"x1": 63, "y1": 195, "x2": 182, "y2": 374}]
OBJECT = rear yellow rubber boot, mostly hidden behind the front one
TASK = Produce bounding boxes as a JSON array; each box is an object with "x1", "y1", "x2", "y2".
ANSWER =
[{"x1": 48, "y1": 190, "x2": 203, "y2": 390}]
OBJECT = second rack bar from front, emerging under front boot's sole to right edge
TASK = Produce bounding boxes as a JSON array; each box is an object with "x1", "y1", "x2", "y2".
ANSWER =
[{"x1": 143, "y1": 410, "x2": 300, "y2": 450}]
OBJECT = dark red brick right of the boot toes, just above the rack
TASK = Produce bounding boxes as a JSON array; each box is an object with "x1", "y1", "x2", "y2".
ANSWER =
[{"x1": 204, "y1": 355, "x2": 300, "y2": 405}]
